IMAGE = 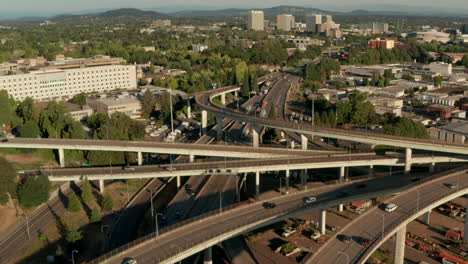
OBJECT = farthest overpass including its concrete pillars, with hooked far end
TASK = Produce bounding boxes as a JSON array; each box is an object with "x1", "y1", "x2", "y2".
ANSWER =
[{"x1": 195, "y1": 87, "x2": 468, "y2": 175}]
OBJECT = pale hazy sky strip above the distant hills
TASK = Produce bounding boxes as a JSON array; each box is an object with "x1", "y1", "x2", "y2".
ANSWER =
[{"x1": 0, "y1": 0, "x2": 468, "y2": 13}]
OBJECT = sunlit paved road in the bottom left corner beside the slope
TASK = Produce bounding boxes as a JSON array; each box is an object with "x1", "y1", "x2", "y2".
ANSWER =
[{"x1": 0, "y1": 185, "x2": 71, "y2": 264}]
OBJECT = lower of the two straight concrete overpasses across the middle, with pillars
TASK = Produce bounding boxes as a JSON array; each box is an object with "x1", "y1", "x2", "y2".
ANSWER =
[{"x1": 35, "y1": 153, "x2": 468, "y2": 195}]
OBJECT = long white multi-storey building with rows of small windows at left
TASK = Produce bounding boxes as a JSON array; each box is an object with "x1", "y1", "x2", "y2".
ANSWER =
[{"x1": 0, "y1": 65, "x2": 137, "y2": 101}]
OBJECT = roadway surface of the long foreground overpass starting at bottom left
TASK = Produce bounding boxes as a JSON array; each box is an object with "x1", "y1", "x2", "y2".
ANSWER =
[{"x1": 91, "y1": 170, "x2": 442, "y2": 263}]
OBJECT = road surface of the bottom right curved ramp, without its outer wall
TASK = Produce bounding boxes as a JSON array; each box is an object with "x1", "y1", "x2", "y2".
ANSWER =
[{"x1": 307, "y1": 170, "x2": 468, "y2": 264}]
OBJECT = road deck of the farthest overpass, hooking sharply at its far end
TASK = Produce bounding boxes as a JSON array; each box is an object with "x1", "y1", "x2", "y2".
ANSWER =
[{"x1": 195, "y1": 87, "x2": 468, "y2": 155}]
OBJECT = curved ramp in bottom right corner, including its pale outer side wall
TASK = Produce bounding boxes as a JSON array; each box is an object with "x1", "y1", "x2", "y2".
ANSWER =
[{"x1": 304, "y1": 169, "x2": 468, "y2": 264}]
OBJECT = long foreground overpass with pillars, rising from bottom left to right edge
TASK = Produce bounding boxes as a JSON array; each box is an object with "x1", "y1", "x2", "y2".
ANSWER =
[{"x1": 85, "y1": 170, "x2": 468, "y2": 264}]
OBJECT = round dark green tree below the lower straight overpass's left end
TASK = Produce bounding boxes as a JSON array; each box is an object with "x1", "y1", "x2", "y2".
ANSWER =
[{"x1": 18, "y1": 173, "x2": 51, "y2": 208}]
